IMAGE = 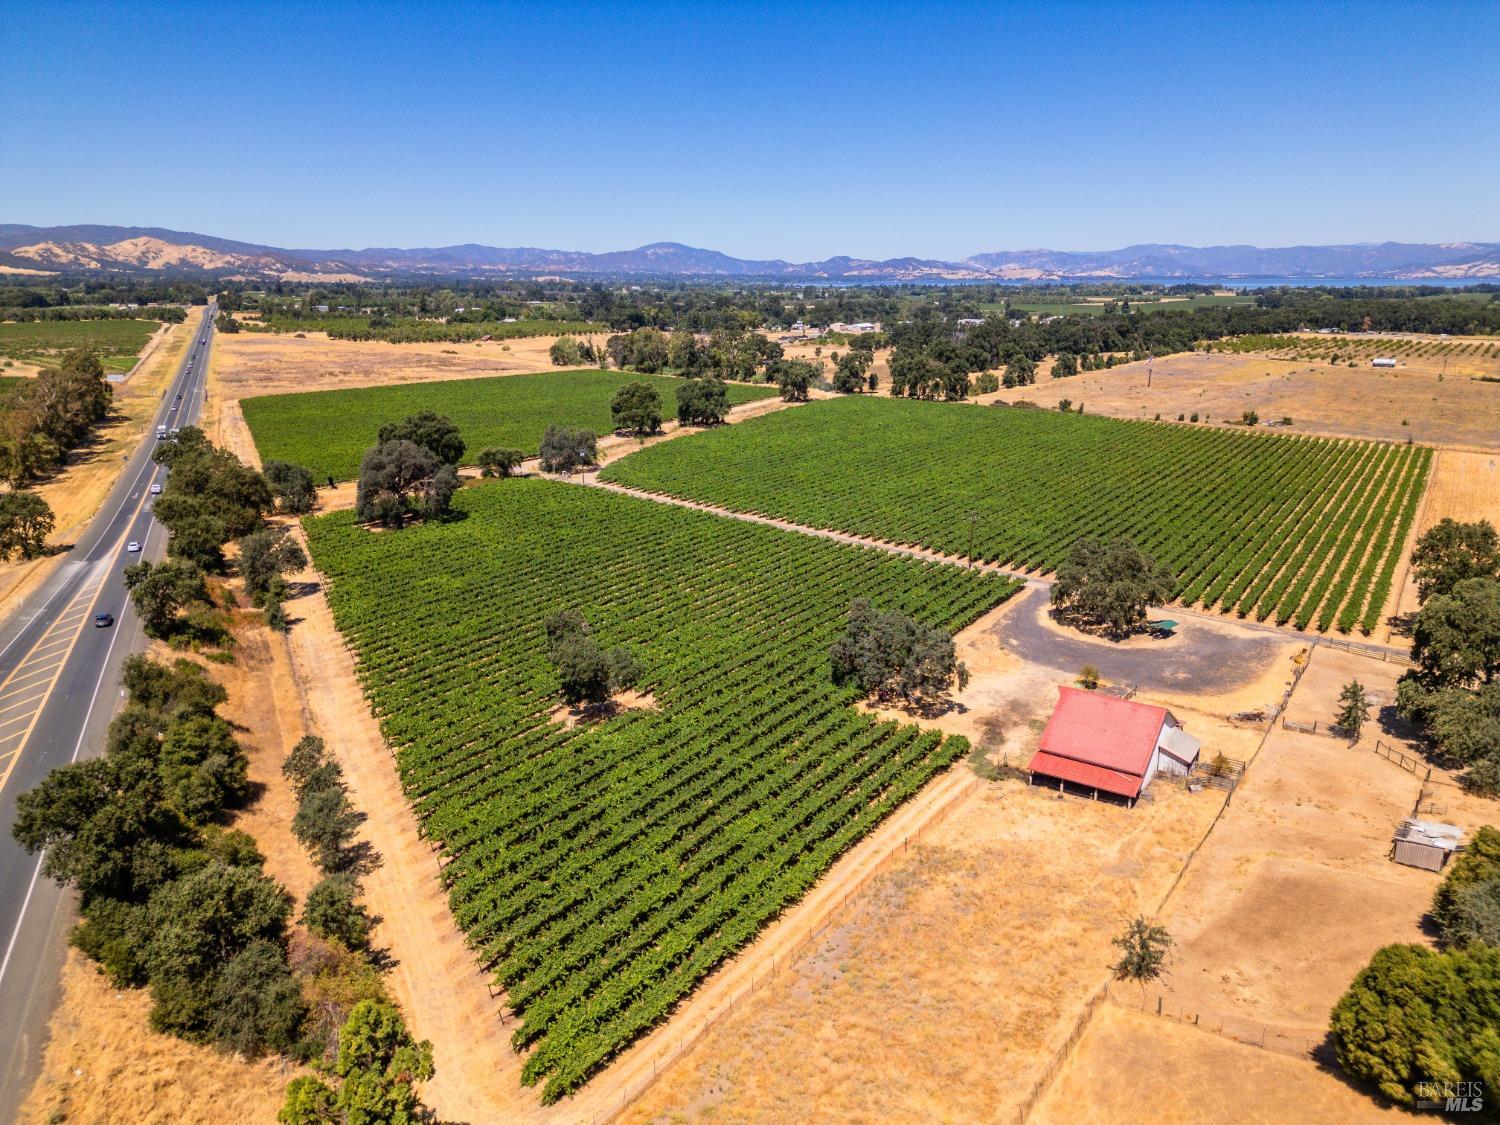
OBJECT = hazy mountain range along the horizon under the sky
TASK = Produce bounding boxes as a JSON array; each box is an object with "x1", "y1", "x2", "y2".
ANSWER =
[{"x1": 0, "y1": 224, "x2": 1500, "y2": 282}]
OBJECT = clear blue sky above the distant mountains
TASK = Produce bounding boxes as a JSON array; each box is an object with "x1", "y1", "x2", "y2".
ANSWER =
[{"x1": 0, "y1": 0, "x2": 1500, "y2": 261}]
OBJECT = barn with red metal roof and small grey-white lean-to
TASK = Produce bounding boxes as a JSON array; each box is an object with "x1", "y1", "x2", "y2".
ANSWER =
[{"x1": 1028, "y1": 687, "x2": 1202, "y2": 804}]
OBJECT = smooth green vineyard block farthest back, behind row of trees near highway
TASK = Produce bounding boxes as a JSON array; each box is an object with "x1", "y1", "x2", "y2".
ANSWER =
[{"x1": 240, "y1": 369, "x2": 776, "y2": 480}]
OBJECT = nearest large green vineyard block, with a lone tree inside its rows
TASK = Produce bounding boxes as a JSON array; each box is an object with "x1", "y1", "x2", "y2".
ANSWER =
[{"x1": 308, "y1": 479, "x2": 1017, "y2": 1101}]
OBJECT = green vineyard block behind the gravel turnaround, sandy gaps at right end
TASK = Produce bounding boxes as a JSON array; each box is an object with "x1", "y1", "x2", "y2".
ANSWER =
[{"x1": 602, "y1": 396, "x2": 1431, "y2": 633}]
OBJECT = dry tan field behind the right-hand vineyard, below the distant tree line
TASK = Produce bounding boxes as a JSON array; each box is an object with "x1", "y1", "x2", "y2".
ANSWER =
[{"x1": 1020, "y1": 343, "x2": 1500, "y2": 449}]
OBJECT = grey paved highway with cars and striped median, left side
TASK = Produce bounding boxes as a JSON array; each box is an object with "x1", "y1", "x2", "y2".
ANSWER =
[{"x1": 0, "y1": 305, "x2": 218, "y2": 1121}]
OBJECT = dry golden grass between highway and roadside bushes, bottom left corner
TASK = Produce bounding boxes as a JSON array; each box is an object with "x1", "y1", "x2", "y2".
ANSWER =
[{"x1": 21, "y1": 950, "x2": 303, "y2": 1125}]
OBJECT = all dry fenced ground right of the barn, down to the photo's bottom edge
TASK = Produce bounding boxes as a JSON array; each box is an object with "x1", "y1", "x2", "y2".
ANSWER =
[{"x1": 1035, "y1": 648, "x2": 1500, "y2": 1122}]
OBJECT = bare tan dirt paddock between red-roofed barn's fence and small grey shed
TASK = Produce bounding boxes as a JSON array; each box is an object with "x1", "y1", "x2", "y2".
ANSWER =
[{"x1": 1154, "y1": 648, "x2": 1452, "y2": 1040}]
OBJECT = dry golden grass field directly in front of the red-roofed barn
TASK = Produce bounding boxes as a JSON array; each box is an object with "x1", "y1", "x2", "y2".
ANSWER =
[{"x1": 624, "y1": 782, "x2": 1220, "y2": 1122}]
